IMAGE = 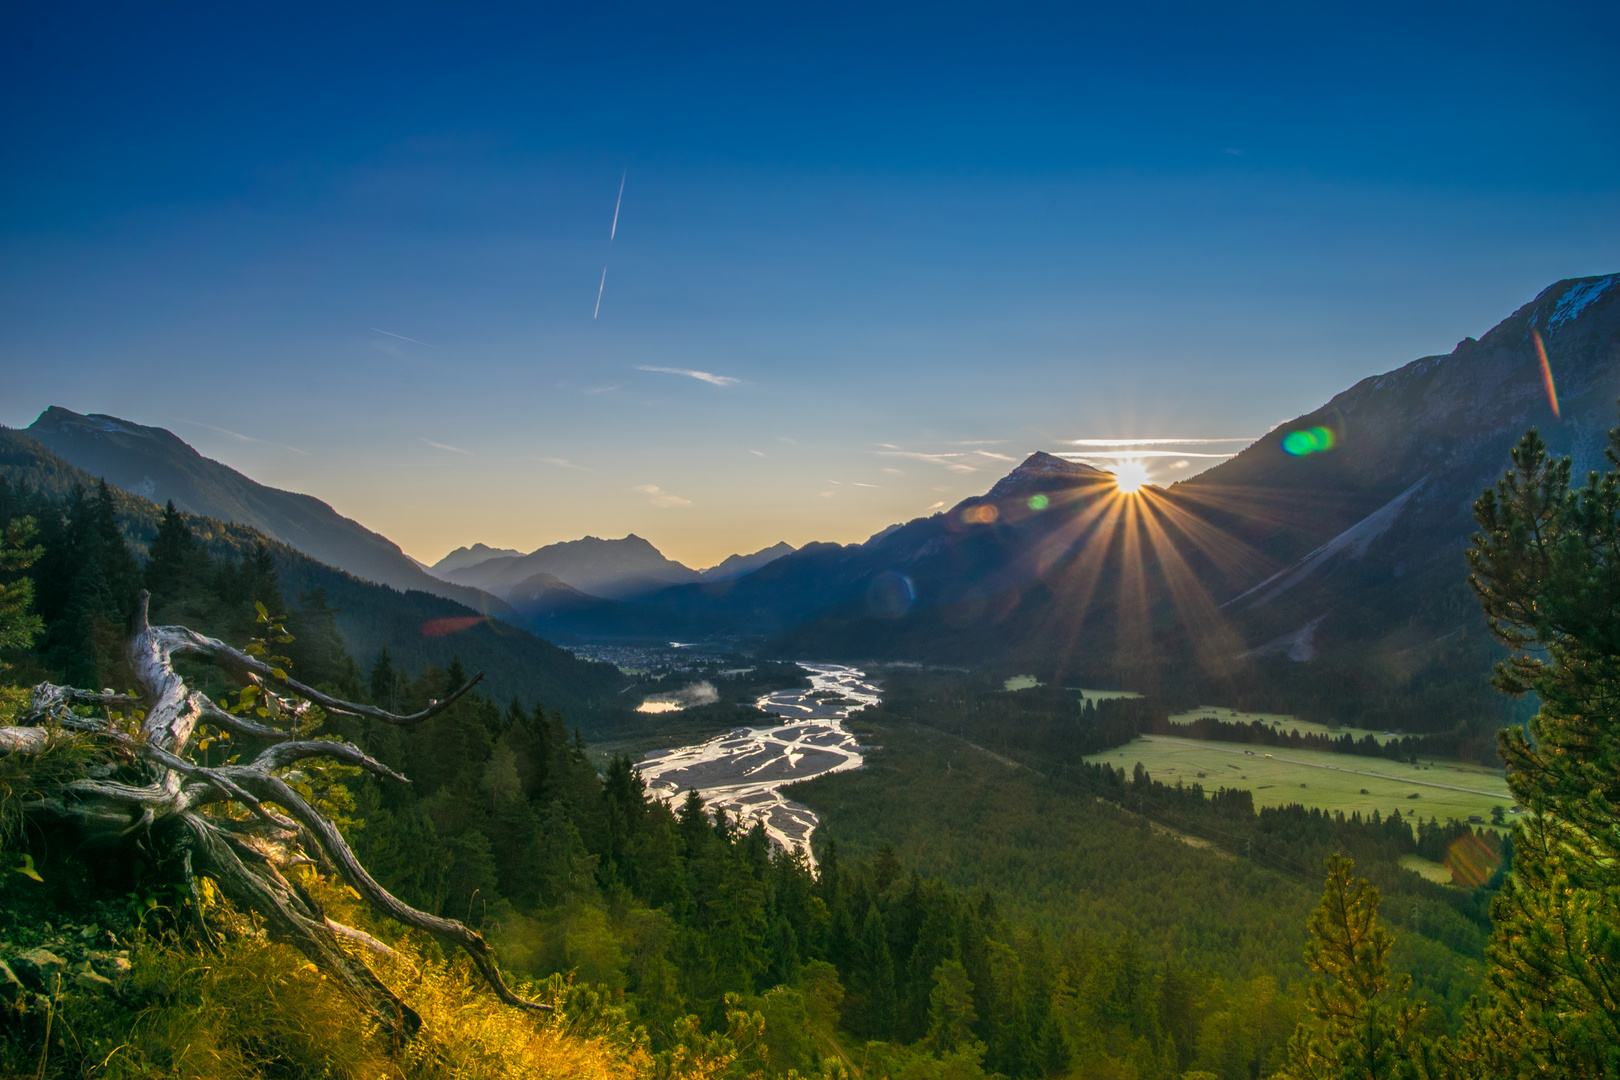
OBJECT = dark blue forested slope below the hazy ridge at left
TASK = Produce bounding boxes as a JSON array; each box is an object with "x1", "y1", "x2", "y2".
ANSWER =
[{"x1": 0, "y1": 427, "x2": 624, "y2": 712}]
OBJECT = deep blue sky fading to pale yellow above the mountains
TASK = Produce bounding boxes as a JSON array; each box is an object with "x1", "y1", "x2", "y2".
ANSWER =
[{"x1": 0, "y1": 0, "x2": 1620, "y2": 567}]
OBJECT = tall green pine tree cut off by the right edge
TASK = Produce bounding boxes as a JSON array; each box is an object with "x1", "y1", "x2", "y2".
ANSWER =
[{"x1": 1458, "y1": 429, "x2": 1620, "y2": 1077}]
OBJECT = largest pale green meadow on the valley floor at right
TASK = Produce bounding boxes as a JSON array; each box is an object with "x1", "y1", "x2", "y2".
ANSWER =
[{"x1": 1087, "y1": 735, "x2": 1513, "y2": 823}]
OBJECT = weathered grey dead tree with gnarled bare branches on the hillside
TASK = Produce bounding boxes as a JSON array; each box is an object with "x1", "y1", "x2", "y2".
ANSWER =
[{"x1": 0, "y1": 591, "x2": 549, "y2": 1036}]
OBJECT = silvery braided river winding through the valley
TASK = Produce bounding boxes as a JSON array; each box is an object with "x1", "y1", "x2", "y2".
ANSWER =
[{"x1": 637, "y1": 664, "x2": 880, "y2": 857}]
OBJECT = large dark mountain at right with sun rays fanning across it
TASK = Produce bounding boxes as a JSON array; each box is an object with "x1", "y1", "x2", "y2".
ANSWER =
[{"x1": 550, "y1": 275, "x2": 1620, "y2": 730}]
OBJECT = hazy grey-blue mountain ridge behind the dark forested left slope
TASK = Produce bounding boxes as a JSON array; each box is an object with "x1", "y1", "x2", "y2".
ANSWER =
[{"x1": 26, "y1": 406, "x2": 510, "y2": 617}]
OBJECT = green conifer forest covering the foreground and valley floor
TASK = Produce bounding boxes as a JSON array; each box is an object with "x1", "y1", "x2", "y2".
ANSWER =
[{"x1": 0, "y1": 424, "x2": 1620, "y2": 1078}]
